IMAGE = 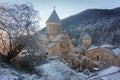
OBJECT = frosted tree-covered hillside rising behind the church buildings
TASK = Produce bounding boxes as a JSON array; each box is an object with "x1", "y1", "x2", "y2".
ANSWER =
[{"x1": 43, "y1": 8, "x2": 120, "y2": 46}]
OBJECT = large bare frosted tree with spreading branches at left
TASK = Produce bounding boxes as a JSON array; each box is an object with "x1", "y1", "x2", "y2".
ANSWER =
[{"x1": 0, "y1": 4, "x2": 39, "y2": 60}]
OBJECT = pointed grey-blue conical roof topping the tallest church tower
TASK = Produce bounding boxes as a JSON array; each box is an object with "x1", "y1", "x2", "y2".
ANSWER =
[{"x1": 46, "y1": 9, "x2": 61, "y2": 23}]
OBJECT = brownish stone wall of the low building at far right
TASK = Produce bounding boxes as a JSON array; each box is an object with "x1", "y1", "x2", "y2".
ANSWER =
[{"x1": 86, "y1": 48, "x2": 116, "y2": 68}]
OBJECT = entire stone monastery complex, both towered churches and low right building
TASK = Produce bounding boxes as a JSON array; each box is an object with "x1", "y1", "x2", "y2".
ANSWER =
[{"x1": 39, "y1": 9, "x2": 120, "y2": 68}]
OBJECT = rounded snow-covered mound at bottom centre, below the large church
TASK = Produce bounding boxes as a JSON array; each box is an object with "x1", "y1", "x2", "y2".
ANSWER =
[{"x1": 35, "y1": 61, "x2": 82, "y2": 80}]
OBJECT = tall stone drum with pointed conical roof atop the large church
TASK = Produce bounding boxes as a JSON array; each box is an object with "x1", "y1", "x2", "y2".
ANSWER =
[{"x1": 46, "y1": 8, "x2": 61, "y2": 41}]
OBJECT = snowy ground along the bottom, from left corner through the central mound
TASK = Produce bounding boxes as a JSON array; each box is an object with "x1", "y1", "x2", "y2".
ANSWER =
[{"x1": 0, "y1": 61, "x2": 86, "y2": 80}]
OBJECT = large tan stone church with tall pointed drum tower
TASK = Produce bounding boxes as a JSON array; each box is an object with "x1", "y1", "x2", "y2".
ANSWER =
[{"x1": 39, "y1": 9, "x2": 75, "y2": 56}]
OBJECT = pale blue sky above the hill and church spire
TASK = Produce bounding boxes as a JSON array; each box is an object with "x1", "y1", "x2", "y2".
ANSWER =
[{"x1": 0, "y1": 0, "x2": 120, "y2": 27}]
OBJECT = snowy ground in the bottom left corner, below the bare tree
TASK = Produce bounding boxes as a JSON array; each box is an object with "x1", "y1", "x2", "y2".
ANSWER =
[{"x1": 0, "y1": 63, "x2": 37, "y2": 80}]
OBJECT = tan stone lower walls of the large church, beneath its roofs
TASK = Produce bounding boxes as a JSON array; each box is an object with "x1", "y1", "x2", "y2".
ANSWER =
[{"x1": 47, "y1": 35, "x2": 75, "y2": 56}]
